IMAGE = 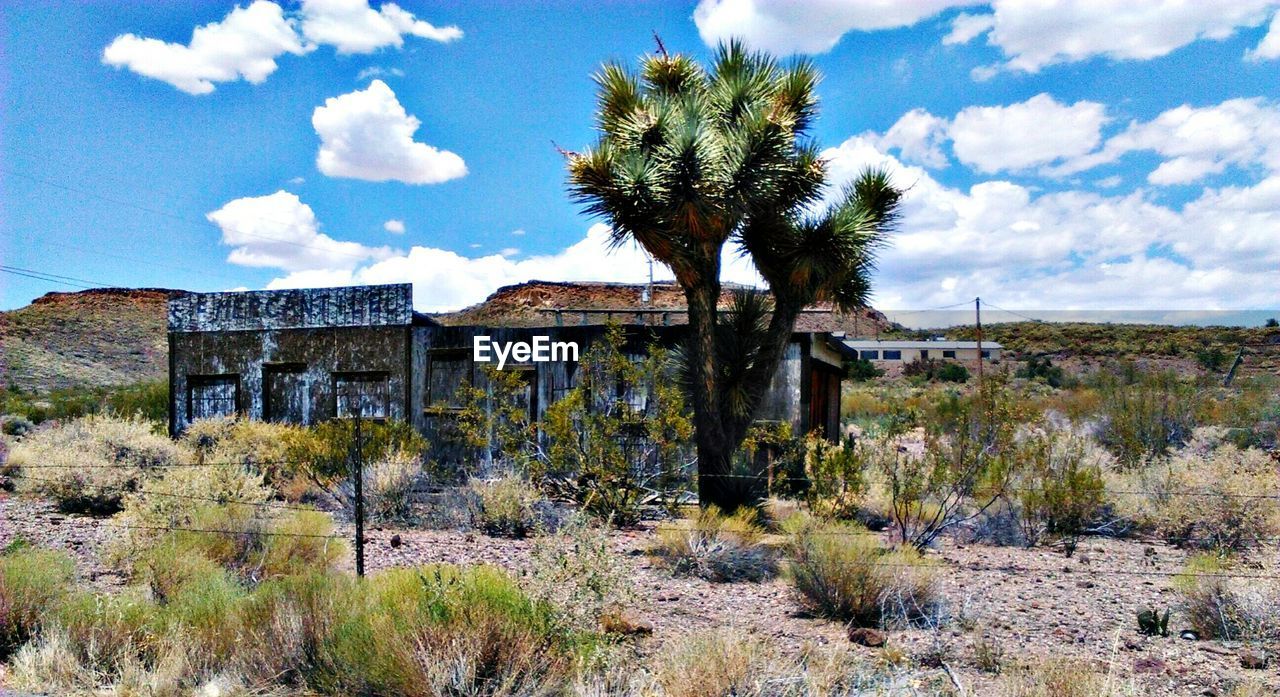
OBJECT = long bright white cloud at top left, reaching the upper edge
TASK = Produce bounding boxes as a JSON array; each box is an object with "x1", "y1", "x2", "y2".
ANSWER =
[{"x1": 102, "y1": 0, "x2": 462, "y2": 95}]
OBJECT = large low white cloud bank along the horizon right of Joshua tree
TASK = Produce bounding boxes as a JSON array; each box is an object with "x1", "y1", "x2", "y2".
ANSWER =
[{"x1": 823, "y1": 137, "x2": 1280, "y2": 311}]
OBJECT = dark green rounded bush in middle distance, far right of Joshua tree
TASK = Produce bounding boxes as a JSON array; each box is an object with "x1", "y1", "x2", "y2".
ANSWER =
[{"x1": 1097, "y1": 371, "x2": 1203, "y2": 467}]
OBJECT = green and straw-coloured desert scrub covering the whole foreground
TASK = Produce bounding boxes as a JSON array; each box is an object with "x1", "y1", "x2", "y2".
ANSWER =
[{"x1": 0, "y1": 335, "x2": 1280, "y2": 696}]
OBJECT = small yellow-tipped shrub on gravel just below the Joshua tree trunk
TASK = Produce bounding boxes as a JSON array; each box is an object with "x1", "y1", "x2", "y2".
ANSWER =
[{"x1": 655, "y1": 506, "x2": 777, "y2": 582}]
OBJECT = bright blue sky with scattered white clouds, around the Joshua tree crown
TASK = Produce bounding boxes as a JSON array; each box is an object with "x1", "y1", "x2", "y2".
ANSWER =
[{"x1": 0, "y1": 0, "x2": 1280, "y2": 318}]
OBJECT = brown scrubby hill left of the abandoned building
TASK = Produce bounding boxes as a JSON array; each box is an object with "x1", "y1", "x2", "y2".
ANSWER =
[{"x1": 0, "y1": 288, "x2": 182, "y2": 393}]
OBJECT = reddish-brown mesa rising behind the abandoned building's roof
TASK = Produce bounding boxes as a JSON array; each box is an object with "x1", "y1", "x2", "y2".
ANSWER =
[{"x1": 434, "y1": 280, "x2": 890, "y2": 335}]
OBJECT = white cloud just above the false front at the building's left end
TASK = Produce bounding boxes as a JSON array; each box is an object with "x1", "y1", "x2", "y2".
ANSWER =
[{"x1": 206, "y1": 191, "x2": 393, "y2": 272}]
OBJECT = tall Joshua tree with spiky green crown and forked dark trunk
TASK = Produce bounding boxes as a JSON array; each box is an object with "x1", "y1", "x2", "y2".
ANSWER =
[{"x1": 567, "y1": 42, "x2": 901, "y2": 509}]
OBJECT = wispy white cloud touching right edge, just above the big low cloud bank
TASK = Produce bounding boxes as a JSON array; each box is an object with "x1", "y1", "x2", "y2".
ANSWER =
[{"x1": 1053, "y1": 98, "x2": 1280, "y2": 185}]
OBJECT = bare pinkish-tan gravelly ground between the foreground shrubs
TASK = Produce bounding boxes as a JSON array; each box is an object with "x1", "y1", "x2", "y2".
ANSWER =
[{"x1": 0, "y1": 494, "x2": 1280, "y2": 694}]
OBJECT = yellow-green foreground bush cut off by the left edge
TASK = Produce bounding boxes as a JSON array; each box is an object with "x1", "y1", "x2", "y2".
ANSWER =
[{"x1": 0, "y1": 547, "x2": 76, "y2": 660}]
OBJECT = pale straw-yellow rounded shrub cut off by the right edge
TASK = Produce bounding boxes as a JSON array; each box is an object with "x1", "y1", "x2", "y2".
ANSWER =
[{"x1": 1144, "y1": 445, "x2": 1280, "y2": 554}]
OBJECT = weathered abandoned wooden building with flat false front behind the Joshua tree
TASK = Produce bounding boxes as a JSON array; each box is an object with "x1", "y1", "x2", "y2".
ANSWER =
[{"x1": 169, "y1": 281, "x2": 884, "y2": 460}]
